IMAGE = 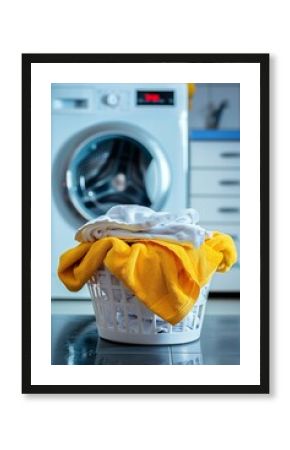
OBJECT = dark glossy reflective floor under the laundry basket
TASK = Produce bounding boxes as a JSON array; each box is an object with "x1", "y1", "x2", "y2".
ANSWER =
[{"x1": 51, "y1": 314, "x2": 240, "y2": 365}]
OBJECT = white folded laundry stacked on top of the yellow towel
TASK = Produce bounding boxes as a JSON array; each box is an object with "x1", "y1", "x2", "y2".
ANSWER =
[{"x1": 75, "y1": 205, "x2": 211, "y2": 247}]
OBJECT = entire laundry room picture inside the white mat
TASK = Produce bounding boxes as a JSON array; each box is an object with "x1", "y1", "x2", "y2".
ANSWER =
[{"x1": 51, "y1": 82, "x2": 240, "y2": 365}]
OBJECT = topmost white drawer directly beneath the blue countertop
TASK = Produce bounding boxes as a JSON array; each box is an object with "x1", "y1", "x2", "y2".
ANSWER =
[{"x1": 190, "y1": 141, "x2": 240, "y2": 168}]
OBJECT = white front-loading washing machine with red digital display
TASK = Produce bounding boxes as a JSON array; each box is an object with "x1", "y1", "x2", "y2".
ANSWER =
[{"x1": 51, "y1": 83, "x2": 188, "y2": 298}]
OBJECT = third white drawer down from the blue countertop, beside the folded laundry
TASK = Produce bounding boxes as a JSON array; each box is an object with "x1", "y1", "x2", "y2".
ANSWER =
[{"x1": 190, "y1": 196, "x2": 240, "y2": 225}]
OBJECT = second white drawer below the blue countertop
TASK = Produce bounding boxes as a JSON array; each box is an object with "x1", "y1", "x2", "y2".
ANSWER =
[{"x1": 190, "y1": 169, "x2": 240, "y2": 195}]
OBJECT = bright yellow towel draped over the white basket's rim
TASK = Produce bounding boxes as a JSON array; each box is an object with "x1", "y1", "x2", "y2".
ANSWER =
[{"x1": 58, "y1": 232, "x2": 237, "y2": 325}]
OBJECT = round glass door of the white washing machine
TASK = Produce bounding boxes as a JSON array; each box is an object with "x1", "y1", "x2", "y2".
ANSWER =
[{"x1": 55, "y1": 123, "x2": 170, "y2": 221}]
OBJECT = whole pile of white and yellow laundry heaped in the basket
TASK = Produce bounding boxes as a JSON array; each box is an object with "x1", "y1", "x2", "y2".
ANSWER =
[{"x1": 58, "y1": 205, "x2": 237, "y2": 325}]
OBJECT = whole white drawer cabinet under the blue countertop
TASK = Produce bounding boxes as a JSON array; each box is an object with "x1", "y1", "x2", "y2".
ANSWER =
[{"x1": 189, "y1": 140, "x2": 240, "y2": 292}]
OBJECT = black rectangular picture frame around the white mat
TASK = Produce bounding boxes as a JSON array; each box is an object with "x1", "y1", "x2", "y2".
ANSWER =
[{"x1": 22, "y1": 53, "x2": 270, "y2": 394}]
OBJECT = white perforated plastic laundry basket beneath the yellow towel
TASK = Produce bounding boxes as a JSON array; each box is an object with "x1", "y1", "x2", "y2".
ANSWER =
[{"x1": 88, "y1": 269, "x2": 209, "y2": 345}]
